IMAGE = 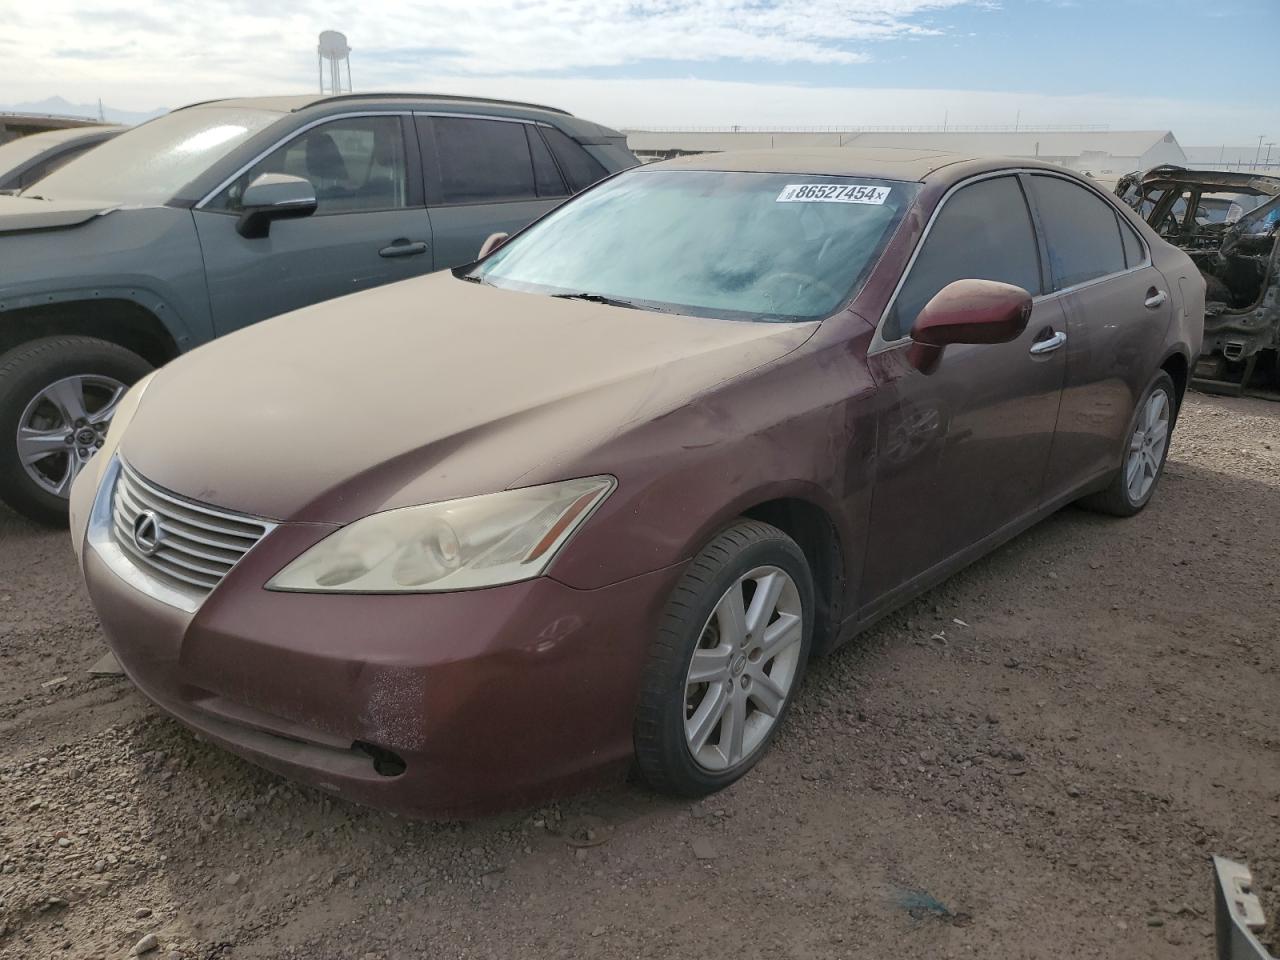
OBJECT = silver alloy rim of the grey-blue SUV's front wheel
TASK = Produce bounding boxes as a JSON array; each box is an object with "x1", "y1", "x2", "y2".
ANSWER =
[{"x1": 17, "y1": 374, "x2": 128, "y2": 498}]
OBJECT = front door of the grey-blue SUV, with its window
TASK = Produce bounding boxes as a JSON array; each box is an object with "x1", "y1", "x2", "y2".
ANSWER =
[{"x1": 195, "y1": 113, "x2": 434, "y2": 334}]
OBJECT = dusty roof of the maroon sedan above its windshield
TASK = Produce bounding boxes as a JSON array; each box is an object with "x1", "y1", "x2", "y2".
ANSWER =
[{"x1": 649, "y1": 147, "x2": 1074, "y2": 180}]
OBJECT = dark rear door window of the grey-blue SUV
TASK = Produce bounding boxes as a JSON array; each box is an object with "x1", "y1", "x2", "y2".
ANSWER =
[{"x1": 431, "y1": 116, "x2": 538, "y2": 204}]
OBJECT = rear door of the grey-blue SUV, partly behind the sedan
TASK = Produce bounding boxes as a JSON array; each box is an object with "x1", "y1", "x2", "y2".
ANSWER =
[{"x1": 415, "y1": 114, "x2": 572, "y2": 269}]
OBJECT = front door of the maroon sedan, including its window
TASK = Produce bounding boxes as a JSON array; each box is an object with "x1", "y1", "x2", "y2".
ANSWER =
[{"x1": 861, "y1": 173, "x2": 1065, "y2": 616}]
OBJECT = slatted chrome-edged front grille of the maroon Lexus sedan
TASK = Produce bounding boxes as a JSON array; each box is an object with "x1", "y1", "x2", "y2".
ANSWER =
[{"x1": 90, "y1": 456, "x2": 276, "y2": 612}]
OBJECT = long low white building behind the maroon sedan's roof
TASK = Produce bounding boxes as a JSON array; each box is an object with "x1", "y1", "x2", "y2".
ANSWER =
[{"x1": 626, "y1": 128, "x2": 1187, "y2": 180}]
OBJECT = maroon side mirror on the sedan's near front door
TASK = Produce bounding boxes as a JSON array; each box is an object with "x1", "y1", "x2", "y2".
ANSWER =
[{"x1": 908, "y1": 280, "x2": 1032, "y2": 374}]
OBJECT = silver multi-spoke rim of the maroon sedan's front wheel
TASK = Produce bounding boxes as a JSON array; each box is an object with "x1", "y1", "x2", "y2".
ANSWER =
[{"x1": 685, "y1": 566, "x2": 804, "y2": 773}]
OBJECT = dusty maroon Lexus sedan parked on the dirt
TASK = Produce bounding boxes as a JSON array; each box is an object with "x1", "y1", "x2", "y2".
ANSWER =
[{"x1": 72, "y1": 150, "x2": 1204, "y2": 814}]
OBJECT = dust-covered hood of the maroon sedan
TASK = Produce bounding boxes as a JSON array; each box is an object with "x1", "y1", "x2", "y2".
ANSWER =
[{"x1": 120, "y1": 273, "x2": 817, "y2": 522}]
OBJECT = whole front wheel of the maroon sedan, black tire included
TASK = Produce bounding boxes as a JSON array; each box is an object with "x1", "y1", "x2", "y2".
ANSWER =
[{"x1": 634, "y1": 520, "x2": 814, "y2": 797}]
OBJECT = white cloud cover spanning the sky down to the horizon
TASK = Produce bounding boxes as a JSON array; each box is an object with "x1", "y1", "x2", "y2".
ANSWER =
[{"x1": 0, "y1": 0, "x2": 1280, "y2": 143}]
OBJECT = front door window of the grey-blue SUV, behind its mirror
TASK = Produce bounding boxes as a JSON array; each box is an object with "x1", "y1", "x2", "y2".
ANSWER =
[{"x1": 211, "y1": 116, "x2": 408, "y2": 216}]
